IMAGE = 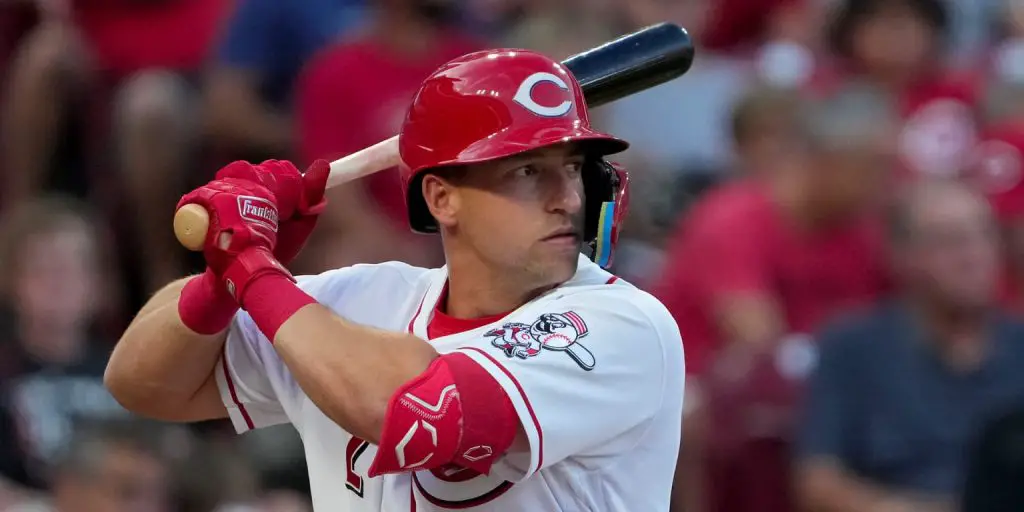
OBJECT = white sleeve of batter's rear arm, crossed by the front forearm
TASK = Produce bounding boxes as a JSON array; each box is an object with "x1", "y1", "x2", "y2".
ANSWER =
[{"x1": 215, "y1": 265, "x2": 407, "y2": 433}]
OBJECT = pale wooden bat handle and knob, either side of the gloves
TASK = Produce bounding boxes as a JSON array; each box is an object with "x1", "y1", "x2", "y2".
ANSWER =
[{"x1": 174, "y1": 135, "x2": 401, "y2": 251}]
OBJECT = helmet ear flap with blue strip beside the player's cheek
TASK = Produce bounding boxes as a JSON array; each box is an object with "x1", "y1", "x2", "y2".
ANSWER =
[{"x1": 583, "y1": 158, "x2": 629, "y2": 268}]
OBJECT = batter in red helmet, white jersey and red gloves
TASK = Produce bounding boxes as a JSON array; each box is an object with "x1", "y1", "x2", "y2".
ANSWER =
[{"x1": 105, "y1": 50, "x2": 684, "y2": 512}]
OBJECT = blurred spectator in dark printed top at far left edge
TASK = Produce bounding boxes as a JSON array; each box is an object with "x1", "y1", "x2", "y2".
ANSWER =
[{"x1": 0, "y1": 193, "x2": 126, "y2": 487}]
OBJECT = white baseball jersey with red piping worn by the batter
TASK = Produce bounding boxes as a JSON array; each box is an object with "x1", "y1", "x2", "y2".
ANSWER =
[{"x1": 217, "y1": 253, "x2": 684, "y2": 512}]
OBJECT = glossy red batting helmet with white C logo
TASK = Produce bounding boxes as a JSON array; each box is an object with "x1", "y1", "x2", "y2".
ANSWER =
[{"x1": 398, "y1": 49, "x2": 629, "y2": 266}]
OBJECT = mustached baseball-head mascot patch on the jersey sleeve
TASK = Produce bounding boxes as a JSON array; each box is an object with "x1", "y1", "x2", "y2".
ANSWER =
[{"x1": 484, "y1": 311, "x2": 597, "y2": 372}]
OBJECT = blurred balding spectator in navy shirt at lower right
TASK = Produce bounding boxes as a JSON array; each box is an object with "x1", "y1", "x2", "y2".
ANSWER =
[{"x1": 797, "y1": 180, "x2": 1024, "y2": 512}]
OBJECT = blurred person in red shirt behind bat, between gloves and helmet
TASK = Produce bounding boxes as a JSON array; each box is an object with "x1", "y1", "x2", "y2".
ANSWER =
[{"x1": 297, "y1": 0, "x2": 483, "y2": 268}]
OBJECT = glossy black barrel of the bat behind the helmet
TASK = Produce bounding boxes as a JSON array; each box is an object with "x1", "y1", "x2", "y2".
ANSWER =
[{"x1": 562, "y1": 23, "x2": 693, "y2": 108}]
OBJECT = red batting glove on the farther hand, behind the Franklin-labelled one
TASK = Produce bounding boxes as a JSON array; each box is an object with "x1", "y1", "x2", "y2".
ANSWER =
[{"x1": 217, "y1": 160, "x2": 331, "y2": 265}]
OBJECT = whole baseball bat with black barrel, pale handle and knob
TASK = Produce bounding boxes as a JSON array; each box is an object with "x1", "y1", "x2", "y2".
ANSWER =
[{"x1": 174, "y1": 23, "x2": 693, "y2": 251}]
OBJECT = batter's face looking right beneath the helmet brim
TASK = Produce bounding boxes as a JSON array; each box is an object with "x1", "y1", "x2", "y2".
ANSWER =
[{"x1": 448, "y1": 145, "x2": 584, "y2": 286}]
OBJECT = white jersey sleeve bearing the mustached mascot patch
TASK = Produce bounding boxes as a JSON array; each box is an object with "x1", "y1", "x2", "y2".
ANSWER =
[{"x1": 456, "y1": 285, "x2": 684, "y2": 481}]
